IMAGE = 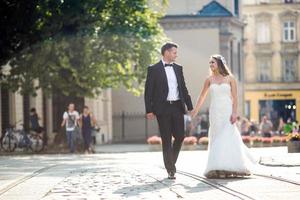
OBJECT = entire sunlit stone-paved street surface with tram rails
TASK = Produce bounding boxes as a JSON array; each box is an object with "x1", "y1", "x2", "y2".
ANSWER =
[{"x1": 0, "y1": 147, "x2": 300, "y2": 200}]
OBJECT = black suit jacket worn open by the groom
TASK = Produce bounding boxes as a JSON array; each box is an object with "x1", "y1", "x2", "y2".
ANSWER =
[{"x1": 144, "y1": 61, "x2": 193, "y2": 115}]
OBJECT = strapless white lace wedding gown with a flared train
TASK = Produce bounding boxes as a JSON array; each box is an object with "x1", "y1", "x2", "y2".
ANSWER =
[{"x1": 204, "y1": 83, "x2": 255, "y2": 177}]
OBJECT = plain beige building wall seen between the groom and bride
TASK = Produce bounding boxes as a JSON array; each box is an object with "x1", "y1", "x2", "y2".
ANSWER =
[{"x1": 165, "y1": 28, "x2": 220, "y2": 110}]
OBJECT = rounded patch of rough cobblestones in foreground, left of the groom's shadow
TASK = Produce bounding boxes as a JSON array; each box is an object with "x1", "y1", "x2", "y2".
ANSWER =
[{"x1": 44, "y1": 167, "x2": 177, "y2": 200}]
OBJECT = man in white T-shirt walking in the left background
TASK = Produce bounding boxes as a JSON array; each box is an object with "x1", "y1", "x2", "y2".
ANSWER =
[{"x1": 61, "y1": 103, "x2": 79, "y2": 153}]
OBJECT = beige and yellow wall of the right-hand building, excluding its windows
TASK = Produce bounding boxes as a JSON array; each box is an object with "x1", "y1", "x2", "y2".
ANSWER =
[{"x1": 243, "y1": 0, "x2": 300, "y2": 121}]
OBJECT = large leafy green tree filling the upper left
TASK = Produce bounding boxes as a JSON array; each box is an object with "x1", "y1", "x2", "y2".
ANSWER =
[{"x1": 0, "y1": 0, "x2": 164, "y2": 96}]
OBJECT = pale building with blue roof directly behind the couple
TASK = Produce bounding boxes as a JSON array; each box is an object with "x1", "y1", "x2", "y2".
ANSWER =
[{"x1": 112, "y1": 0, "x2": 244, "y2": 141}]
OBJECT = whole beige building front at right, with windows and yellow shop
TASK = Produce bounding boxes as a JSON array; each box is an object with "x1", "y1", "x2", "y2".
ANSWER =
[{"x1": 243, "y1": 0, "x2": 300, "y2": 128}]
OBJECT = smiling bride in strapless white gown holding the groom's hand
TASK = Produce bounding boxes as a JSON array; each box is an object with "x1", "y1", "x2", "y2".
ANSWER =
[{"x1": 191, "y1": 55, "x2": 254, "y2": 178}]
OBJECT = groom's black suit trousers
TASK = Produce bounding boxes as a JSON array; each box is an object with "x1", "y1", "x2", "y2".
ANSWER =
[{"x1": 156, "y1": 101, "x2": 184, "y2": 172}]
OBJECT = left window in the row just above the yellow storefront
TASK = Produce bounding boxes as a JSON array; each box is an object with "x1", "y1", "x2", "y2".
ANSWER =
[{"x1": 257, "y1": 58, "x2": 271, "y2": 82}]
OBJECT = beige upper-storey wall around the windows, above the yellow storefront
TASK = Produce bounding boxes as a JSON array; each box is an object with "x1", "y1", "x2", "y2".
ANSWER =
[{"x1": 244, "y1": 4, "x2": 300, "y2": 82}]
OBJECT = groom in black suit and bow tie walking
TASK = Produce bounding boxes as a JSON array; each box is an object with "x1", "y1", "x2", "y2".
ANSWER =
[{"x1": 145, "y1": 43, "x2": 193, "y2": 179}]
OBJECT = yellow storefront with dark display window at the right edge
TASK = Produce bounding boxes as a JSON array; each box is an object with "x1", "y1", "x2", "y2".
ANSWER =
[{"x1": 245, "y1": 90, "x2": 300, "y2": 124}]
